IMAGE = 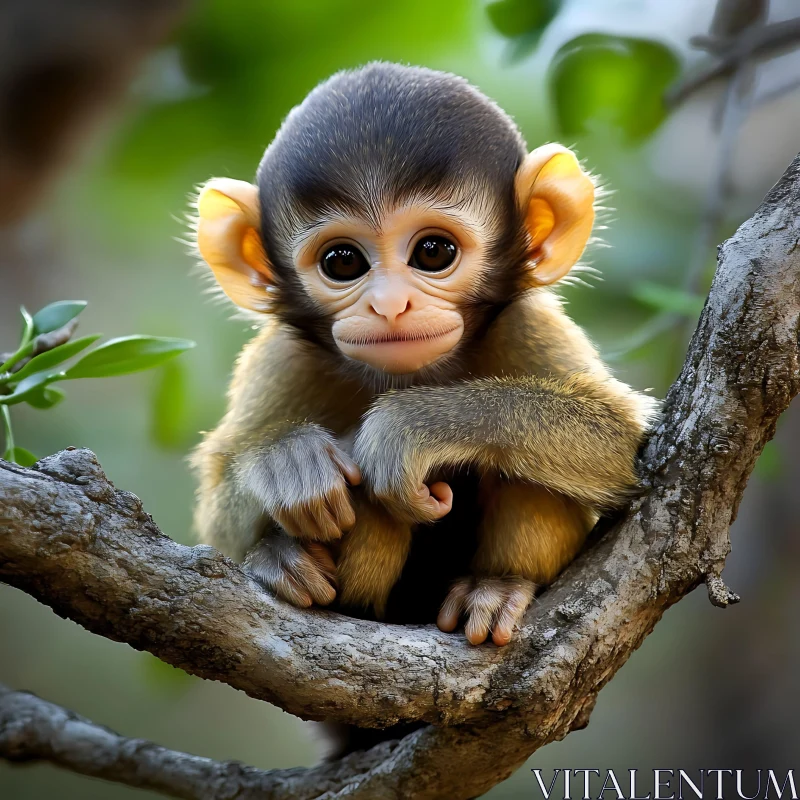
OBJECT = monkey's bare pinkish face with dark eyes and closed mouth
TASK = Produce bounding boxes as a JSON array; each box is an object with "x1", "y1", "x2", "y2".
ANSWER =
[{"x1": 293, "y1": 203, "x2": 486, "y2": 375}]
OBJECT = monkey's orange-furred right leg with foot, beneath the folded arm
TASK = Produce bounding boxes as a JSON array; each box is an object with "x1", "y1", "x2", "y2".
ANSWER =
[{"x1": 437, "y1": 478, "x2": 597, "y2": 645}]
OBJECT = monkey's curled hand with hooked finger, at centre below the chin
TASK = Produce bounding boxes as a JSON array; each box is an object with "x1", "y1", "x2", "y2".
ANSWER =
[{"x1": 354, "y1": 406, "x2": 453, "y2": 523}]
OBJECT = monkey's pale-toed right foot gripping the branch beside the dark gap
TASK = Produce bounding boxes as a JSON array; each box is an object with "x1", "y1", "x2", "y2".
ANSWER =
[{"x1": 436, "y1": 577, "x2": 536, "y2": 645}]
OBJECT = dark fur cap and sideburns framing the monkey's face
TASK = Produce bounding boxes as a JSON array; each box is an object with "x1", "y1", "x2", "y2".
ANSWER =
[{"x1": 257, "y1": 62, "x2": 527, "y2": 380}]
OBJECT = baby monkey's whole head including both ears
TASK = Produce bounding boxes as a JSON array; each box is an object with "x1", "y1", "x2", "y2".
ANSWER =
[{"x1": 197, "y1": 63, "x2": 594, "y2": 377}]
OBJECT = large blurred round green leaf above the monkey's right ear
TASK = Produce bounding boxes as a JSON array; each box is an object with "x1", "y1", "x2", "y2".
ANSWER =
[{"x1": 548, "y1": 33, "x2": 680, "y2": 143}]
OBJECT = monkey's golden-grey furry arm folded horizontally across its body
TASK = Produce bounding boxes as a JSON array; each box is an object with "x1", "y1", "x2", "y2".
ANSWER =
[{"x1": 354, "y1": 371, "x2": 655, "y2": 521}]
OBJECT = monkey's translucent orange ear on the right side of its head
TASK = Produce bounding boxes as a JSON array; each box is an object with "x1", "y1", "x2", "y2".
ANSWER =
[{"x1": 516, "y1": 144, "x2": 594, "y2": 286}]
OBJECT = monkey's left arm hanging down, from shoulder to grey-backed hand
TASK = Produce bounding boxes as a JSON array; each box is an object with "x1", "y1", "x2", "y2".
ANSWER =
[{"x1": 193, "y1": 322, "x2": 368, "y2": 560}]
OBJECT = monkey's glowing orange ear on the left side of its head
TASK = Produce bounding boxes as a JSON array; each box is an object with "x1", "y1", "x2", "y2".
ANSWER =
[{"x1": 197, "y1": 178, "x2": 273, "y2": 311}]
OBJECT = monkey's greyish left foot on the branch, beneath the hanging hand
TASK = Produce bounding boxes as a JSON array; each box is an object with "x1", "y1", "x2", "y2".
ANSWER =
[{"x1": 242, "y1": 535, "x2": 336, "y2": 608}]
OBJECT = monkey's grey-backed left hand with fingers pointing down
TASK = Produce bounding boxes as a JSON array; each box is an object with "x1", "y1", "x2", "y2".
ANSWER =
[{"x1": 238, "y1": 425, "x2": 361, "y2": 542}]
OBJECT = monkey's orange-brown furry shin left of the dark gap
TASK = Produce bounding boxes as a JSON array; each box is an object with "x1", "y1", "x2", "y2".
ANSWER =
[{"x1": 336, "y1": 490, "x2": 411, "y2": 619}]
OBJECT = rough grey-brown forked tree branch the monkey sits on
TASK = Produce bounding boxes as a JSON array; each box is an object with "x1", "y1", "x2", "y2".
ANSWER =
[{"x1": 0, "y1": 156, "x2": 800, "y2": 800}]
